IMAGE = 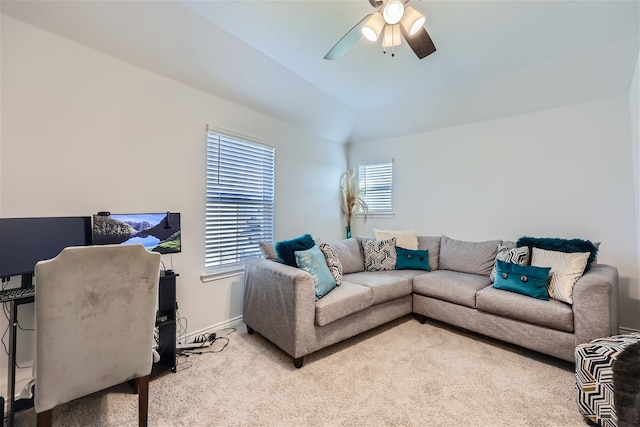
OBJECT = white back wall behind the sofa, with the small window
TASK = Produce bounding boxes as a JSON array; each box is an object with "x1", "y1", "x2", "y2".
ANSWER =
[{"x1": 349, "y1": 97, "x2": 640, "y2": 329}]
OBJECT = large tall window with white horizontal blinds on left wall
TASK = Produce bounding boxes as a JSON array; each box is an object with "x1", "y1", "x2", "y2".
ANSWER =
[{"x1": 205, "y1": 129, "x2": 275, "y2": 274}]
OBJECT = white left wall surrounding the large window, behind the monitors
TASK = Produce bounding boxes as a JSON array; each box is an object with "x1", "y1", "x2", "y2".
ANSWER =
[{"x1": 0, "y1": 15, "x2": 346, "y2": 388}]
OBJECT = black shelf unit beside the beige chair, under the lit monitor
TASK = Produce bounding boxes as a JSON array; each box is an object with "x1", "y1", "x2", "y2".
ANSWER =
[{"x1": 151, "y1": 272, "x2": 179, "y2": 378}]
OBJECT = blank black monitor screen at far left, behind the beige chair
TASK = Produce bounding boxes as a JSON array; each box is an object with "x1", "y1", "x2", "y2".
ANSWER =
[{"x1": 0, "y1": 216, "x2": 91, "y2": 277}]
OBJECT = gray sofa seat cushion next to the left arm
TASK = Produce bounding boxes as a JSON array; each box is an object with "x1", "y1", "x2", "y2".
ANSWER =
[{"x1": 316, "y1": 280, "x2": 373, "y2": 326}]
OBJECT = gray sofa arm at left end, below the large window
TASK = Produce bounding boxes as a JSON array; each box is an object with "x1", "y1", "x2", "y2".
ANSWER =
[{"x1": 243, "y1": 258, "x2": 316, "y2": 358}]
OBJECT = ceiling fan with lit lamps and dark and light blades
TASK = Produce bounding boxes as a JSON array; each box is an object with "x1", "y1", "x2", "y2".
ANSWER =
[{"x1": 324, "y1": 0, "x2": 436, "y2": 59}]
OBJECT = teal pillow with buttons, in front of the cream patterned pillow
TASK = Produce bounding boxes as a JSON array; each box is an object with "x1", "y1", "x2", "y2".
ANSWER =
[{"x1": 493, "y1": 260, "x2": 551, "y2": 301}]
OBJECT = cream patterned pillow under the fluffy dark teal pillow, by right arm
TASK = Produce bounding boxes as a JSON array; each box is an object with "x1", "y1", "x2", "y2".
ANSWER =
[{"x1": 531, "y1": 248, "x2": 589, "y2": 304}]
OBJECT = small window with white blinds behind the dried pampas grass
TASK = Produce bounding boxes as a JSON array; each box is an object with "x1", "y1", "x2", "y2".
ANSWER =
[{"x1": 358, "y1": 162, "x2": 393, "y2": 216}]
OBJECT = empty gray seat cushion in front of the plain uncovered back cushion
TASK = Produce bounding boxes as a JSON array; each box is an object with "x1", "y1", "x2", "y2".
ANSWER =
[{"x1": 413, "y1": 270, "x2": 491, "y2": 308}]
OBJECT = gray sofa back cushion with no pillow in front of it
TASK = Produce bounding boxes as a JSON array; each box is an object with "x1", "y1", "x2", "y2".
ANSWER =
[{"x1": 440, "y1": 236, "x2": 502, "y2": 276}]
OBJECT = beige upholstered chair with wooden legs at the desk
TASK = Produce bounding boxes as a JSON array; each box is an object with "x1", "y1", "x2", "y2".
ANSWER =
[{"x1": 34, "y1": 245, "x2": 160, "y2": 426}]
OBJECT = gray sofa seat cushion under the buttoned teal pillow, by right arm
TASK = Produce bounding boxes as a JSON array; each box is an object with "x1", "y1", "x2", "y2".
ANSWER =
[{"x1": 476, "y1": 287, "x2": 573, "y2": 332}]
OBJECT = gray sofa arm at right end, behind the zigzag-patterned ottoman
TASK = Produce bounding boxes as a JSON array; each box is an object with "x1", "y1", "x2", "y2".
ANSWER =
[{"x1": 573, "y1": 264, "x2": 618, "y2": 346}]
